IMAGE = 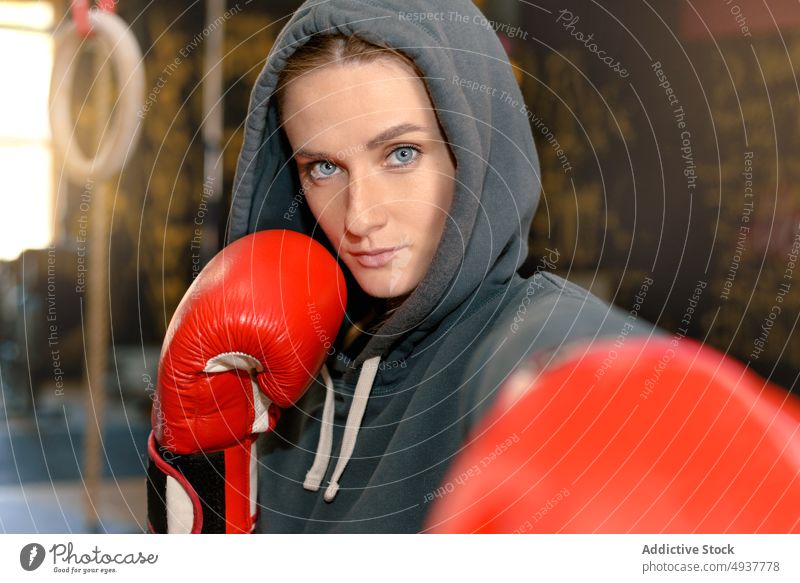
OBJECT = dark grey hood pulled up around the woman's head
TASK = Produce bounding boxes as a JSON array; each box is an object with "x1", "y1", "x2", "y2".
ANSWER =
[{"x1": 228, "y1": 0, "x2": 540, "y2": 378}]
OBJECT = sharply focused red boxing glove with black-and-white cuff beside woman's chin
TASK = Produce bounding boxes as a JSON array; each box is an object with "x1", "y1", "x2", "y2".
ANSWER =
[{"x1": 148, "y1": 230, "x2": 347, "y2": 533}]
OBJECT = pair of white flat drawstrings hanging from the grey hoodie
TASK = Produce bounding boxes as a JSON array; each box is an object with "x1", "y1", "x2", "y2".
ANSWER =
[{"x1": 303, "y1": 356, "x2": 381, "y2": 502}]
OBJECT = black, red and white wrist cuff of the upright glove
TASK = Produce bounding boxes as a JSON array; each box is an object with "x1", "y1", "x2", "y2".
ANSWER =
[{"x1": 147, "y1": 433, "x2": 257, "y2": 534}]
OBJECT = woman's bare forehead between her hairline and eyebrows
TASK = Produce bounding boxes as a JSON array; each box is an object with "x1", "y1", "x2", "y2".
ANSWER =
[{"x1": 283, "y1": 59, "x2": 434, "y2": 139}]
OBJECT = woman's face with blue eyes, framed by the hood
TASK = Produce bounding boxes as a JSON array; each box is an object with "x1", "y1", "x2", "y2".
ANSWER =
[{"x1": 282, "y1": 59, "x2": 455, "y2": 298}]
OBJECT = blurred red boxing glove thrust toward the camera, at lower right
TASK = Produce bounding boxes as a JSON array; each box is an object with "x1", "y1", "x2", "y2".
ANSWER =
[{"x1": 427, "y1": 338, "x2": 800, "y2": 533}]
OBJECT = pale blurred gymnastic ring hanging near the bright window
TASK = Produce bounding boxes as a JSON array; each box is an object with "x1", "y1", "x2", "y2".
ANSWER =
[{"x1": 50, "y1": 10, "x2": 144, "y2": 183}]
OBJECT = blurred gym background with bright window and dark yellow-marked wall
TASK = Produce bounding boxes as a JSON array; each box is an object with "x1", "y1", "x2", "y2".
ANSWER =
[{"x1": 0, "y1": 0, "x2": 800, "y2": 533}]
